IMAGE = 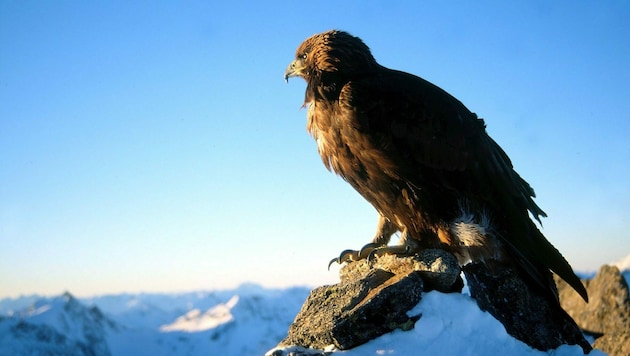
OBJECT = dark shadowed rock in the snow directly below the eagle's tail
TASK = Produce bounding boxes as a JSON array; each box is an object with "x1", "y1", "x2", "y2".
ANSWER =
[{"x1": 463, "y1": 263, "x2": 592, "y2": 353}]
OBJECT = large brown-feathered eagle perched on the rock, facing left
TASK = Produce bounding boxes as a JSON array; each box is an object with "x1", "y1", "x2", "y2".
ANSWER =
[{"x1": 285, "y1": 31, "x2": 587, "y2": 306}]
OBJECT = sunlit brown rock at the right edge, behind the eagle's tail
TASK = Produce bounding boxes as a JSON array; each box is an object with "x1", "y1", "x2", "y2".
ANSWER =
[{"x1": 555, "y1": 265, "x2": 630, "y2": 355}]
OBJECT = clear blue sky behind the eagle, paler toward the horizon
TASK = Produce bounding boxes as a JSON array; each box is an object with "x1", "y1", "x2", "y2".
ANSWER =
[{"x1": 0, "y1": 0, "x2": 630, "y2": 297}]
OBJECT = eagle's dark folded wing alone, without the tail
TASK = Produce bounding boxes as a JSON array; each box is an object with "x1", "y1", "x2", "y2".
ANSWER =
[{"x1": 339, "y1": 68, "x2": 546, "y2": 214}]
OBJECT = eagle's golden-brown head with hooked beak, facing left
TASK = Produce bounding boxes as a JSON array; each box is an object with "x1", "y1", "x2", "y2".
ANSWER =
[{"x1": 284, "y1": 30, "x2": 378, "y2": 89}]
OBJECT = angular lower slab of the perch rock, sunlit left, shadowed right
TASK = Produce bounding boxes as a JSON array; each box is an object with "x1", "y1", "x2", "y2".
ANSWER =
[{"x1": 281, "y1": 269, "x2": 422, "y2": 350}]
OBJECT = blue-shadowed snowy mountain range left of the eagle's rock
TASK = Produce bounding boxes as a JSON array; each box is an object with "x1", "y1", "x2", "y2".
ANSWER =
[{"x1": 0, "y1": 284, "x2": 310, "y2": 355}]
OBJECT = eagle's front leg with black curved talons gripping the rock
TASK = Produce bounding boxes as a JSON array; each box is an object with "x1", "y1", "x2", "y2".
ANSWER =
[{"x1": 328, "y1": 214, "x2": 398, "y2": 269}]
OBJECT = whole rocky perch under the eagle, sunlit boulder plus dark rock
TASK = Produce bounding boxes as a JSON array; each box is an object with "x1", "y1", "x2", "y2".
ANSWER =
[{"x1": 267, "y1": 250, "x2": 591, "y2": 356}]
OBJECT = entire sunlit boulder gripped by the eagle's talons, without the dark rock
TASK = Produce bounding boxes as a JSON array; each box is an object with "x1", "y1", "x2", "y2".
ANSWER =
[{"x1": 267, "y1": 250, "x2": 462, "y2": 356}]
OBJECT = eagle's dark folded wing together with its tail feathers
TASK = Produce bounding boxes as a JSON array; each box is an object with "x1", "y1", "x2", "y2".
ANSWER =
[{"x1": 339, "y1": 67, "x2": 587, "y2": 299}]
